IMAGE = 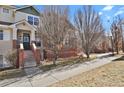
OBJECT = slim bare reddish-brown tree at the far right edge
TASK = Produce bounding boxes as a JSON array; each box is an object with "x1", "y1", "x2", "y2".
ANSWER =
[{"x1": 111, "y1": 17, "x2": 123, "y2": 54}]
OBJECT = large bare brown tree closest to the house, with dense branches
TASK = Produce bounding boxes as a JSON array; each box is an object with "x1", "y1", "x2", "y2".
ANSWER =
[{"x1": 38, "y1": 6, "x2": 70, "y2": 64}]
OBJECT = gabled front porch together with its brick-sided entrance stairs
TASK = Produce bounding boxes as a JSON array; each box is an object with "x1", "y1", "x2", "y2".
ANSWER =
[{"x1": 12, "y1": 20, "x2": 40, "y2": 68}]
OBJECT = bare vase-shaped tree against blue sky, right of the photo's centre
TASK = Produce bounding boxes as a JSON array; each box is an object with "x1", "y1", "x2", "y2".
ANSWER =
[{"x1": 75, "y1": 6, "x2": 104, "y2": 58}]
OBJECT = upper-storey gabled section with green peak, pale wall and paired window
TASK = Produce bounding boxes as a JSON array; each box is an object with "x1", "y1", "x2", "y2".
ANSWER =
[{"x1": 15, "y1": 6, "x2": 40, "y2": 26}]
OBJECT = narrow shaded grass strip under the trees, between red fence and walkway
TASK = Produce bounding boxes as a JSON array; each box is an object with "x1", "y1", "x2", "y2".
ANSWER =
[{"x1": 39, "y1": 57, "x2": 95, "y2": 71}]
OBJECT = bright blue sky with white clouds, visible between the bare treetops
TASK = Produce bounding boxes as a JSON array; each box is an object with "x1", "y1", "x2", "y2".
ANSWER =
[{"x1": 36, "y1": 5, "x2": 124, "y2": 31}]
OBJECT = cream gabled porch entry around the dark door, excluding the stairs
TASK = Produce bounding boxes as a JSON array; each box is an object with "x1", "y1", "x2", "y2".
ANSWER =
[{"x1": 12, "y1": 21, "x2": 36, "y2": 50}]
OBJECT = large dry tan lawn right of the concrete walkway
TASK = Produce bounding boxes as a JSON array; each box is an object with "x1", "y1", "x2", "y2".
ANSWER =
[{"x1": 51, "y1": 56, "x2": 124, "y2": 87}]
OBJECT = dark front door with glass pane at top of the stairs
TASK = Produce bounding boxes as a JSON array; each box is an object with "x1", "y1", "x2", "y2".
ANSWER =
[{"x1": 23, "y1": 33, "x2": 30, "y2": 50}]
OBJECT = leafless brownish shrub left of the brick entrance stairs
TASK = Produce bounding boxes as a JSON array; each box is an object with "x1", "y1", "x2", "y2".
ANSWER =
[{"x1": 5, "y1": 50, "x2": 17, "y2": 67}]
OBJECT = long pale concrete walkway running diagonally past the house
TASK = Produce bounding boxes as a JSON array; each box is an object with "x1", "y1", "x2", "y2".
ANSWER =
[{"x1": 0, "y1": 53, "x2": 120, "y2": 87}]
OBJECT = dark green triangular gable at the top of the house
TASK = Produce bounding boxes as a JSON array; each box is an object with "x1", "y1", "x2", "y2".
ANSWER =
[{"x1": 16, "y1": 5, "x2": 40, "y2": 16}]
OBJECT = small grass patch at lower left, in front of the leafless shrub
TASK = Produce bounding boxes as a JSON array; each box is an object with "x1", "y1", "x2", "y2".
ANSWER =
[{"x1": 0, "y1": 69, "x2": 26, "y2": 80}]
